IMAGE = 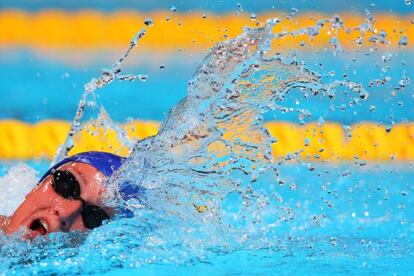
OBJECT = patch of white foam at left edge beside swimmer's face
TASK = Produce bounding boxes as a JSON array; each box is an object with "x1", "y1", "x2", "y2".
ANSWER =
[{"x1": 0, "y1": 163, "x2": 38, "y2": 216}]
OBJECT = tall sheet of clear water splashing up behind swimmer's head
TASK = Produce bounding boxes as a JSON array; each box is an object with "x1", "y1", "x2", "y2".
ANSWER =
[{"x1": 102, "y1": 20, "x2": 367, "y2": 256}]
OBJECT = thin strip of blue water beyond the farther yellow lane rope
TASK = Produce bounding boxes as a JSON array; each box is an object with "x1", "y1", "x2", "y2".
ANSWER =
[{"x1": 0, "y1": 0, "x2": 412, "y2": 14}]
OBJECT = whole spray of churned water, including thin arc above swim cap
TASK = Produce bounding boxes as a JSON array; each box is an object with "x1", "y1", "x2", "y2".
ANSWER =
[{"x1": 0, "y1": 14, "x2": 409, "y2": 273}]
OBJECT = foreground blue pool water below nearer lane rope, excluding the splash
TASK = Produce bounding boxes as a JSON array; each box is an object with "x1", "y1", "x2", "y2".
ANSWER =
[{"x1": 0, "y1": 162, "x2": 414, "y2": 275}]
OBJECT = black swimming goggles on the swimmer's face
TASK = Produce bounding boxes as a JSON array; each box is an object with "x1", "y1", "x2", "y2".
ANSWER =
[{"x1": 52, "y1": 170, "x2": 109, "y2": 229}]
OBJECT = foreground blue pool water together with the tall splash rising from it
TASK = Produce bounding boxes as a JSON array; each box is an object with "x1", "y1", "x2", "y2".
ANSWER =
[{"x1": 0, "y1": 17, "x2": 414, "y2": 274}]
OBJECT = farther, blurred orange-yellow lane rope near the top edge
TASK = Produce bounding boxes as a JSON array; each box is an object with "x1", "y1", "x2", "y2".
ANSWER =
[{"x1": 0, "y1": 9, "x2": 414, "y2": 52}]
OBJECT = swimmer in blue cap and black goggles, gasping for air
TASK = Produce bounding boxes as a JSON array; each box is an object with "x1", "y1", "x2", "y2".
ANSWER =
[{"x1": 0, "y1": 152, "x2": 131, "y2": 239}]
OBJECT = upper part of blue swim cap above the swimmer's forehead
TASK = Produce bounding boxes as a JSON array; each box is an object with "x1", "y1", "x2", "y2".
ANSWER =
[{"x1": 39, "y1": 151, "x2": 126, "y2": 182}]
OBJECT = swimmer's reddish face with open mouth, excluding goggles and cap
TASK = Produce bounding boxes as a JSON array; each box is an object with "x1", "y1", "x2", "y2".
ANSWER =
[{"x1": 0, "y1": 162, "x2": 105, "y2": 239}]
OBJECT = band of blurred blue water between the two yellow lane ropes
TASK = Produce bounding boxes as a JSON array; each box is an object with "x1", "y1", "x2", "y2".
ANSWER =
[{"x1": 0, "y1": 49, "x2": 414, "y2": 124}]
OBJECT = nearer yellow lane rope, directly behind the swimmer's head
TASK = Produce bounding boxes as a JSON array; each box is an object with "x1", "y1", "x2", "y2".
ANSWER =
[{"x1": 0, "y1": 120, "x2": 414, "y2": 162}]
